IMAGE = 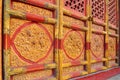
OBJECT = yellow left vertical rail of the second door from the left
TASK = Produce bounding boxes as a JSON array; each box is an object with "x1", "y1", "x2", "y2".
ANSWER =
[{"x1": 57, "y1": 0, "x2": 64, "y2": 80}]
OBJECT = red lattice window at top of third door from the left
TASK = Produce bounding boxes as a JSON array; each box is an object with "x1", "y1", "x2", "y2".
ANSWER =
[{"x1": 91, "y1": 0, "x2": 105, "y2": 21}]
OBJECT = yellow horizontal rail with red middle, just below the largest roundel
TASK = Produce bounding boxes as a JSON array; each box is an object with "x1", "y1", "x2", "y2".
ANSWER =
[{"x1": 8, "y1": 63, "x2": 56, "y2": 75}]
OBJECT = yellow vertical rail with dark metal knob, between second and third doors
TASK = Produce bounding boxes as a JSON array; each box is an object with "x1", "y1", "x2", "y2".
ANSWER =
[{"x1": 86, "y1": 0, "x2": 92, "y2": 74}]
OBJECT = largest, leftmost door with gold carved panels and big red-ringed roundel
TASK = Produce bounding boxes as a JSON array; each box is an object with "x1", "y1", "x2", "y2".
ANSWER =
[{"x1": 4, "y1": 0, "x2": 58, "y2": 80}]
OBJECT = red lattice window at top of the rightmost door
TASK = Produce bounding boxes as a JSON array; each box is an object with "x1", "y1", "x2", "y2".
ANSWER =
[{"x1": 108, "y1": 0, "x2": 117, "y2": 25}]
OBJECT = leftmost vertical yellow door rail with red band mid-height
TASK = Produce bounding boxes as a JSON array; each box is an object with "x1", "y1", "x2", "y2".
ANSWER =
[{"x1": 3, "y1": 0, "x2": 10, "y2": 80}]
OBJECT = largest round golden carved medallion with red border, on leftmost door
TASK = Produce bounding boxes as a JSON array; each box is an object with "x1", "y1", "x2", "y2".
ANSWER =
[{"x1": 11, "y1": 22, "x2": 52, "y2": 63}]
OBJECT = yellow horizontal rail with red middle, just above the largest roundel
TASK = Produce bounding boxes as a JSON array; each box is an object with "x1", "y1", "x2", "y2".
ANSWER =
[{"x1": 7, "y1": 10, "x2": 56, "y2": 24}]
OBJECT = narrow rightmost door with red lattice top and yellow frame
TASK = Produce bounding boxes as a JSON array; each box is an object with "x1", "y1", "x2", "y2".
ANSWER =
[{"x1": 108, "y1": 0, "x2": 119, "y2": 68}]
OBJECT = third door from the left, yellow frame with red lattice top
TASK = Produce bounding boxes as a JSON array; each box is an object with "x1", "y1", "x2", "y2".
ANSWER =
[{"x1": 90, "y1": 0, "x2": 108, "y2": 72}]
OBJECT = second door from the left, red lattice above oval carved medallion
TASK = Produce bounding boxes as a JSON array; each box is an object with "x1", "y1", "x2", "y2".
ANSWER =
[{"x1": 60, "y1": 0, "x2": 90, "y2": 80}]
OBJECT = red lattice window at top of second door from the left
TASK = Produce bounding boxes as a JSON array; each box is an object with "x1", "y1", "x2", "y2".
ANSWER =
[{"x1": 64, "y1": 0, "x2": 86, "y2": 14}]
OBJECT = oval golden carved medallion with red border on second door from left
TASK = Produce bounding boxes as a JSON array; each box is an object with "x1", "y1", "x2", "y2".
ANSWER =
[{"x1": 62, "y1": 30, "x2": 84, "y2": 60}]
